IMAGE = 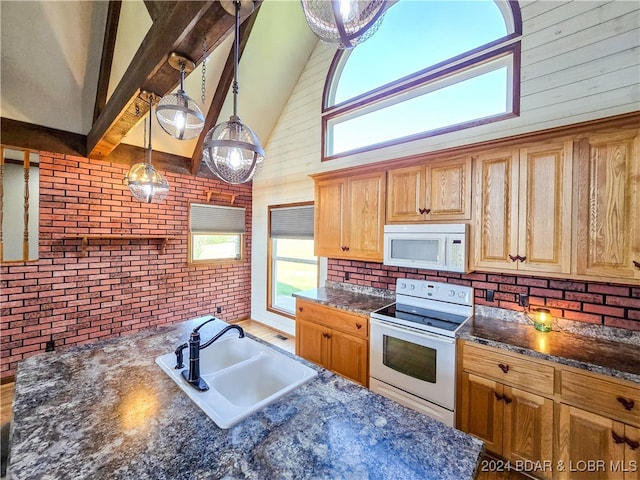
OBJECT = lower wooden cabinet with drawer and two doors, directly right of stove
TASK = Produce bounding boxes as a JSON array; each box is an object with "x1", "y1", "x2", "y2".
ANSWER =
[{"x1": 458, "y1": 343, "x2": 554, "y2": 478}]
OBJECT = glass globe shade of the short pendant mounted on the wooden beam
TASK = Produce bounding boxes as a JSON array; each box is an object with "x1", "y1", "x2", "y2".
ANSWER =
[{"x1": 156, "y1": 90, "x2": 204, "y2": 140}]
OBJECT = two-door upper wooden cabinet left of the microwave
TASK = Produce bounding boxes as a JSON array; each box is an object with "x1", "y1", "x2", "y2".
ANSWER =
[{"x1": 315, "y1": 172, "x2": 385, "y2": 262}]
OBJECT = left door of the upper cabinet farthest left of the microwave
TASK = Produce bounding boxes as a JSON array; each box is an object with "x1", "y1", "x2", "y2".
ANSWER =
[{"x1": 314, "y1": 179, "x2": 346, "y2": 257}]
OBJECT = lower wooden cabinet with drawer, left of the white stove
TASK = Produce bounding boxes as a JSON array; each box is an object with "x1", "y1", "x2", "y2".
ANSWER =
[{"x1": 296, "y1": 299, "x2": 369, "y2": 387}]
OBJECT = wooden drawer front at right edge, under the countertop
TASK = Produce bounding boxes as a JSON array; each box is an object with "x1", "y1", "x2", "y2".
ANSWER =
[{"x1": 560, "y1": 370, "x2": 640, "y2": 426}]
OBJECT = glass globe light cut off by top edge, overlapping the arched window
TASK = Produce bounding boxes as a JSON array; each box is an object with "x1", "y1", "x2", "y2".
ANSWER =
[{"x1": 300, "y1": 0, "x2": 388, "y2": 49}]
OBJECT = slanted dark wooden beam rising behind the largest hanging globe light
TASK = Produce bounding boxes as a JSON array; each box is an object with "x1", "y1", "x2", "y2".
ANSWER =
[{"x1": 191, "y1": 2, "x2": 262, "y2": 175}]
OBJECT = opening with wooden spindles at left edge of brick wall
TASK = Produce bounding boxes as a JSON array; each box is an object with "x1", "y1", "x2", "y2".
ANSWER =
[{"x1": 0, "y1": 147, "x2": 40, "y2": 262}]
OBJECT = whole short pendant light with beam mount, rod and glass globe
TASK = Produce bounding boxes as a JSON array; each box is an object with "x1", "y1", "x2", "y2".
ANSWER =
[{"x1": 156, "y1": 53, "x2": 204, "y2": 140}]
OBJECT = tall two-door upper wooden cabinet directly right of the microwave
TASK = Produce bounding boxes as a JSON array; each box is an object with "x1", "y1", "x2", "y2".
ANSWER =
[{"x1": 474, "y1": 141, "x2": 573, "y2": 273}]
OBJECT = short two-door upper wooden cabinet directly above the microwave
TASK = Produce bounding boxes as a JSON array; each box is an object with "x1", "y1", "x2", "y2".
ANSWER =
[{"x1": 387, "y1": 156, "x2": 471, "y2": 223}]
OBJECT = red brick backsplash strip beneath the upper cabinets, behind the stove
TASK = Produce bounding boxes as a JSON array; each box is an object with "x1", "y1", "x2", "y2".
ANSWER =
[{"x1": 327, "y1": 259, "x2": 640, "y2": 330}]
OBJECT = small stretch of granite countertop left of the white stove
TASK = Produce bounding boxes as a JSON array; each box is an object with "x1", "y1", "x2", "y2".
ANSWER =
[{"x1": 293, "y1": 281, "x2": 395, "y2": 317}]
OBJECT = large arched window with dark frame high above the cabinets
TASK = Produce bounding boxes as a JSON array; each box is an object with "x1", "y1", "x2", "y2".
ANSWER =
[{"x1": 322, "y1": 0, "x2": 522, "y2": 160}]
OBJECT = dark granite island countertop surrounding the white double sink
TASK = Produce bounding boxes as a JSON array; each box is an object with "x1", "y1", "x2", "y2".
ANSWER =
[{"x1": 9, "y1": 319, "x2": 483, "y2": 480}]
